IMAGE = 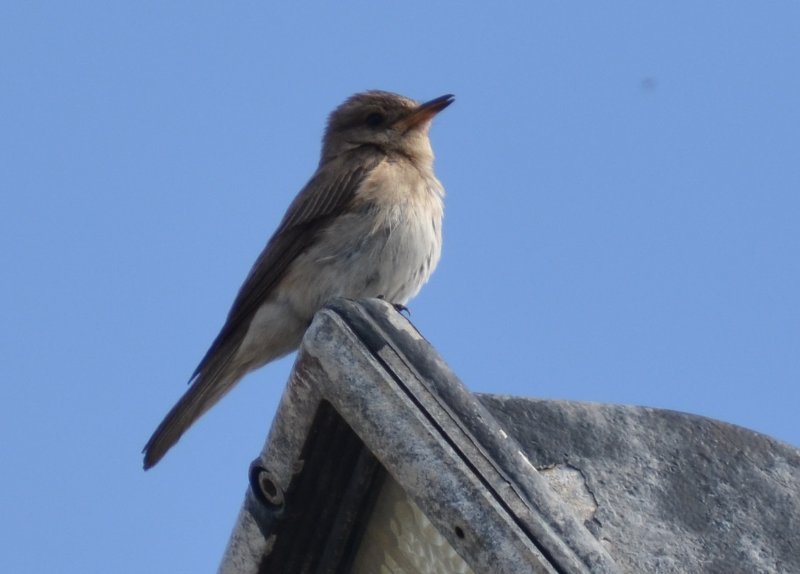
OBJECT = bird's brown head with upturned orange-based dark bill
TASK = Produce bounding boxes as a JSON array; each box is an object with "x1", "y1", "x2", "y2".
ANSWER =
[{"x1": 321, "y1": 90, "x2": 455, "y2": 163}]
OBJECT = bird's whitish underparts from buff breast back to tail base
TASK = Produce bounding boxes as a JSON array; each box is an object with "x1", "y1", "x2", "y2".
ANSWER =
[{"x1": 237, "y1": 159, "x2": 444, "y2": 368}]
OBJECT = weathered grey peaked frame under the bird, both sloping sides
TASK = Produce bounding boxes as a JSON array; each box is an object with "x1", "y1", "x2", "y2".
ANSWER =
[{"x1": 220, "y1": 300, "x2": 619, "y2": 574}]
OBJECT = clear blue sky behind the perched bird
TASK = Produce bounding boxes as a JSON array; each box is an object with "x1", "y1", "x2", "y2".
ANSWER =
[{"x1": 0, "y1": 1, "x2": 800, "y2": 573}]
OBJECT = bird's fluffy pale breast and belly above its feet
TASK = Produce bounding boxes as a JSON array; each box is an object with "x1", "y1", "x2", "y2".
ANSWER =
[{"x1": 280, "y1": 162, "x2": 444, "y2": 316}]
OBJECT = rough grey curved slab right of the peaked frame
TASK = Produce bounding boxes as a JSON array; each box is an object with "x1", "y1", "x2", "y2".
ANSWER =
[{"x1": 479, "y1": 395, "x2": 800, "y2": 574}]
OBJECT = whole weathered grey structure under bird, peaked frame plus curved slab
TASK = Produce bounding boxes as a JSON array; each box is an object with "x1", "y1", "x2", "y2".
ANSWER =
[{"x1": 220, "y1": 300, "x2": 800, "y2": 574}]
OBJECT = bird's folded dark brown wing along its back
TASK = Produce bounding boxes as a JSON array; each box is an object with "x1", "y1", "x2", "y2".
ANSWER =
[{"x1": 191, "y1": 148, "x2": 383, "y2": 380}]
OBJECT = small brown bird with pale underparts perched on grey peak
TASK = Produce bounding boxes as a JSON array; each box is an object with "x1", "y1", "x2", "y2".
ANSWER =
[{"x1": 142, "y1": 90, "x2": 455, "y2": 470}]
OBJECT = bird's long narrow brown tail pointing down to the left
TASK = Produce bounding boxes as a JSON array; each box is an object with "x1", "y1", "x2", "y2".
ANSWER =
[{"x1": 142, "y1": 371, "x2": 244, "y2": 470}]
